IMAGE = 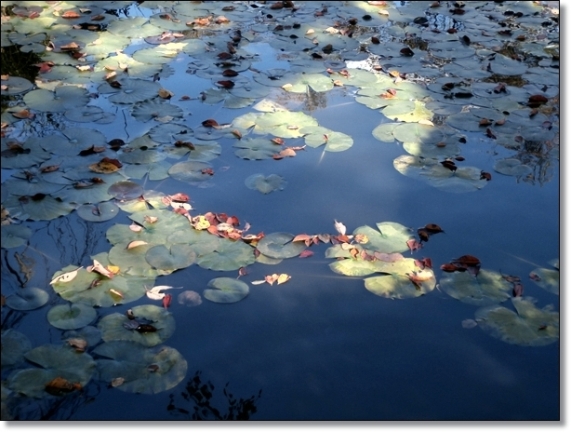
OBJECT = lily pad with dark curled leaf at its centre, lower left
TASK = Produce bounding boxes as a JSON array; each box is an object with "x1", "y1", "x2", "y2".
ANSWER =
[{"x1": 97, "y1": 304, "x2": 175, "y2": 347}]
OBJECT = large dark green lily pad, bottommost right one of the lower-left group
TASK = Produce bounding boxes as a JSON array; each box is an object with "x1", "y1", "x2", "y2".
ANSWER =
[{"x1": 94, "y1": 341, "x2": 188, "y2": 394}]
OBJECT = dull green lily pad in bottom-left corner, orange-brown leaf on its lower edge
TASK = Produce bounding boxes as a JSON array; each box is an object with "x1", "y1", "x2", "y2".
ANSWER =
[{"x1": 8, "y1": 345, "x2": 95, "y2": 398}]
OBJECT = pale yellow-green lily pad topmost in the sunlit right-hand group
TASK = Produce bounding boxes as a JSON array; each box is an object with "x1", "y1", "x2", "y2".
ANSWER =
[{"x1": 353, "y1": 222, "x2": 413, "y2": 253}]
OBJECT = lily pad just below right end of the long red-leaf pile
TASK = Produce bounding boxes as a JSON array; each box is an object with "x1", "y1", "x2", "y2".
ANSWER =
[{"x1": 199, "y1": 237, "x2": 256, "y2": 271}]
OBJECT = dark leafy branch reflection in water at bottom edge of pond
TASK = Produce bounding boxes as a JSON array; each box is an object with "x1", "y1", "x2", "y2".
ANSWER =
[{"x1": 167, "y1": 371, "x2": 262, "y2": 420}]
